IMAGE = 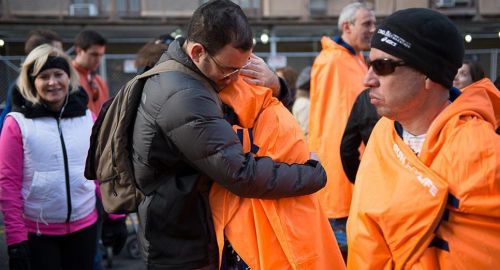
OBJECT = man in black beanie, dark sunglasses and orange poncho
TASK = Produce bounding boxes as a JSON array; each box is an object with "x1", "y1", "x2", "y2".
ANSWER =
[{"x1": 347, "y1": 8, "x2": 500, "y2": 269}]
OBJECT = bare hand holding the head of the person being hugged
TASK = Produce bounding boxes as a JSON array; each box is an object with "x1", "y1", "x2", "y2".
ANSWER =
[{"x1": 240, "y1": 54, "x2": 280, "y2": 97}]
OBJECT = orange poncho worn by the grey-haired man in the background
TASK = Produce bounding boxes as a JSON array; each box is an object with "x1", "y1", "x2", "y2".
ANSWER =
[{"x1": 308, "y1": 37, "x2": 367, "y2": 218}]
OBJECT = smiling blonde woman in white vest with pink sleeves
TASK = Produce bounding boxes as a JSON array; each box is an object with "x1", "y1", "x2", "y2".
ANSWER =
[{"x1": 0, "y1": 45, "x2": 97, "y2": 270}]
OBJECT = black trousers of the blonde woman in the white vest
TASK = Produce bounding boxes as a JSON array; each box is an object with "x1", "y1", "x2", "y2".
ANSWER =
[{"x1": 28, "y1": 224, "x2": 97, "y2": 270}]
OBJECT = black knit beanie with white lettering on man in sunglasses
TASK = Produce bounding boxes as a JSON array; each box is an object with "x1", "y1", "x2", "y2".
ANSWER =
[{"x1": 371, "y1": 8, "x2": 464, "y2": 88}]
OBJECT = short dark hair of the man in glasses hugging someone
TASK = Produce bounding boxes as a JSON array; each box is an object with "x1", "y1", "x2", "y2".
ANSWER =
[{"x1": 187, "y1": 0, "x2": 253, "y2": 55}]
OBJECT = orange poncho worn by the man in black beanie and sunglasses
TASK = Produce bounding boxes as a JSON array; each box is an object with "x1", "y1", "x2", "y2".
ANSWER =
[{"x1": 347, "y1": 79, "x2": 500, "y2": 270}]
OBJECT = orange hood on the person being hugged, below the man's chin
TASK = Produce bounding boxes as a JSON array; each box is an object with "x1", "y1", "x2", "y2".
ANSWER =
[{"x1": 219, "y1": 75, "x2": 279, "y2": 128}]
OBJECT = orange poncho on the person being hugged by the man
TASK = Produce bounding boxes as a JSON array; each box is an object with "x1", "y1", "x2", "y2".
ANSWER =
[{"x1": 210, "y1": 78, "x2": 345, "y2": 270}]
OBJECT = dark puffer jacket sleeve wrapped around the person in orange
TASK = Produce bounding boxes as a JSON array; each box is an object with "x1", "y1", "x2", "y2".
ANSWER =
[{"x1": 157, "y1": 84, "x2": 326, "y2": 199}]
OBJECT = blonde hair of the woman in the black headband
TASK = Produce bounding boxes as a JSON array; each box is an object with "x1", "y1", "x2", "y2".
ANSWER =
[{"x1": 17, "y1": 44, "x2": 80, "y2": 104}]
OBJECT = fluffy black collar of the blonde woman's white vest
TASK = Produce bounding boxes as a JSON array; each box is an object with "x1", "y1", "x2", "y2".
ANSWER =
[{"x1": 12, "y1": 84, "x2": 88, "y2": 118}]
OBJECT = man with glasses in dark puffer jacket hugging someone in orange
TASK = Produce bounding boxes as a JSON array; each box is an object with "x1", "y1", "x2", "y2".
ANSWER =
[{"x1": 132, "y1": 0, "x2": 326, "y2": 269}]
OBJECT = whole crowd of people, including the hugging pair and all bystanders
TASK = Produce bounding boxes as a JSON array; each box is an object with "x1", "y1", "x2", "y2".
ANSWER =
[{"x1": 0, "y1": 0, "x2": 500, "y2": 270}]
